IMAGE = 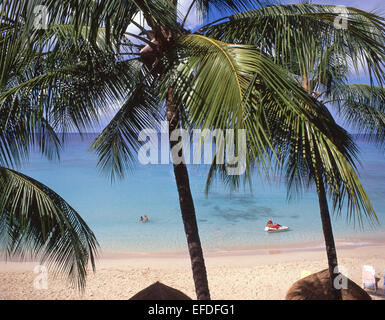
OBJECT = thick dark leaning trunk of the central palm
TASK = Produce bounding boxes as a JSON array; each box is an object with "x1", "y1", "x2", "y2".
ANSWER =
[{"x1": 166, "y1": 89, "x2": 210, "y2": 300}]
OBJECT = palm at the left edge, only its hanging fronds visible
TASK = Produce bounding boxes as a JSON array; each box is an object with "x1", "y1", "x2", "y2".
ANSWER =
[{"x1": 0, "y1": 2, "x2": 98, "y2": 290}]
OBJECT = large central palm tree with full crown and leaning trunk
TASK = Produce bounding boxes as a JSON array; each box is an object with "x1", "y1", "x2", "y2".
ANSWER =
[{"x1": 1, "y1": 0, "x2": 380, "y2": 299}]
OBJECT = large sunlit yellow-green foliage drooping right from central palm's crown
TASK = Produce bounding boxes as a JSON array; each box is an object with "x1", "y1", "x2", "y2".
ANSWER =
[{"x1": 165, "y1": 35, "x2": 375, "y2": 225}]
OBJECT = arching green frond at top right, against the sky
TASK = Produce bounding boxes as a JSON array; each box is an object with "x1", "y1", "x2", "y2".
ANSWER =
[{"x1": 203, "y1": 4, "x2": 385, "y2": 84}]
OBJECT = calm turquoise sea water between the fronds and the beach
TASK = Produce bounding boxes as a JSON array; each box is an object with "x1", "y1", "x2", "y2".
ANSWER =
[{"x1": 20, "y1": 134, "x2": 385, "y2": 252}]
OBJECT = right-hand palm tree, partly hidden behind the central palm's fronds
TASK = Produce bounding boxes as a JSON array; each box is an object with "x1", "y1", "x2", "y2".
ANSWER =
[{"x1": 201, "y1": 4, "x2": 385, "y2": 299}]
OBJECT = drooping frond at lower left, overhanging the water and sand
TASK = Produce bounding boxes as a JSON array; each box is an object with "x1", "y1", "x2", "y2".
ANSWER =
[{"x1": 0, "y1": 167, "x2": 99, "y2": 289}]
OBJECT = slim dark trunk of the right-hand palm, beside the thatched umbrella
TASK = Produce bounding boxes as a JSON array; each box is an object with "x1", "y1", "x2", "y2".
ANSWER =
[{"x1": 317, "y1": 175, "x2": 342, "y2": 300}]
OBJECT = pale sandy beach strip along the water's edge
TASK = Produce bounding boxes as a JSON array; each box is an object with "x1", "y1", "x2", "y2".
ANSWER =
[{"x1": 0, "y1": 244, "x2": 385, "y2": 300}]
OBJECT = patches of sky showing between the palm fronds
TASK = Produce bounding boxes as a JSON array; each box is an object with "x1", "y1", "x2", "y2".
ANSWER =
[{"x1": 94, "y1": 0, "x2": 385, "y2": 132}]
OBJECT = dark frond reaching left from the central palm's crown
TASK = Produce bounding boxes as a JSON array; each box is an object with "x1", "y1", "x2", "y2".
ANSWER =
[{"x1": 0, "y1": 43, "x2": 140, "y2": 133}]
